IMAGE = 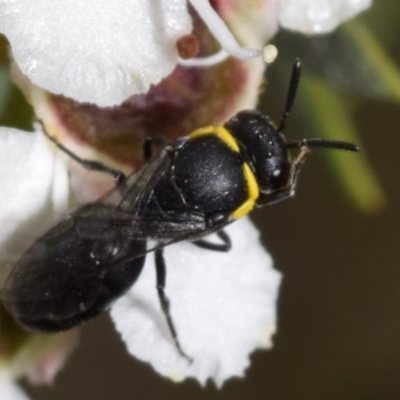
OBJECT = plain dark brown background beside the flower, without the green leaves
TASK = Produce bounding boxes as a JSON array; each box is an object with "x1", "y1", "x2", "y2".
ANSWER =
[{"x1": 15, "y1": 0, "x2": 400, "y2": 400}]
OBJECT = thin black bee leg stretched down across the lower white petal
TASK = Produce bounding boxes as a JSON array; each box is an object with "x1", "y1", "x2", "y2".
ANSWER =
[{"x1": 155, "y1": 249, "x2": 193, "y2": 363}]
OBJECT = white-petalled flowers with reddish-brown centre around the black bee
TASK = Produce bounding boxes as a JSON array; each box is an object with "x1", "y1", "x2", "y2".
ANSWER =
[{"x1": 0, "y1": 0, "x2": 371, "y2": 399}]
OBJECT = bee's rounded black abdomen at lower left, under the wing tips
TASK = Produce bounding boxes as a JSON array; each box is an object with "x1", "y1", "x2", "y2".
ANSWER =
[{"x1": 1, "y1": 203, "x2": 146, "y2": 332}]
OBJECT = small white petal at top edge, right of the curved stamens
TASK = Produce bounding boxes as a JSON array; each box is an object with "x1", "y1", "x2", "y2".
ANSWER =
[{"x1": 280, "y1": 0, "x2": 372, "y2": 34}]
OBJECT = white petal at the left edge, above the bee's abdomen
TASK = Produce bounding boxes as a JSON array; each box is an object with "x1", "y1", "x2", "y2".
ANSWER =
[{"x1": 0, "y1": 128, "x2": 68, "y2": 272}]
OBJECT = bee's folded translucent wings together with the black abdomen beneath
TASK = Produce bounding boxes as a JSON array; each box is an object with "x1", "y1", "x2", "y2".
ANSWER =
[{"x1": 1, "y1": 152, "x2": 209, "y2": 332}]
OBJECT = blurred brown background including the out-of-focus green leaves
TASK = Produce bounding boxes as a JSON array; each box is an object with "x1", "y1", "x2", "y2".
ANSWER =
[{"x1": 4, "y1": 0, "x2": 400, "y2": 400}]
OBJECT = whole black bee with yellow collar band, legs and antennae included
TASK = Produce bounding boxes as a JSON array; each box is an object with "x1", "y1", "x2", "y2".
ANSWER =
[{"x1": 1, "y1": 60, "x2": 358, "y2": 357}]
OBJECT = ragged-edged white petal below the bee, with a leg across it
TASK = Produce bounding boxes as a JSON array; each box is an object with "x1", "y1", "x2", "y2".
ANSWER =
[{"x1": 111, "y1": 218, "x2": 280, "y2": 386}]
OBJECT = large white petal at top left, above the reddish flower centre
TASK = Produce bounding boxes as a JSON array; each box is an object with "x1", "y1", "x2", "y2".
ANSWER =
[{"x1": 0, "y1": 0, "x2": 192, "y2": 106}]
